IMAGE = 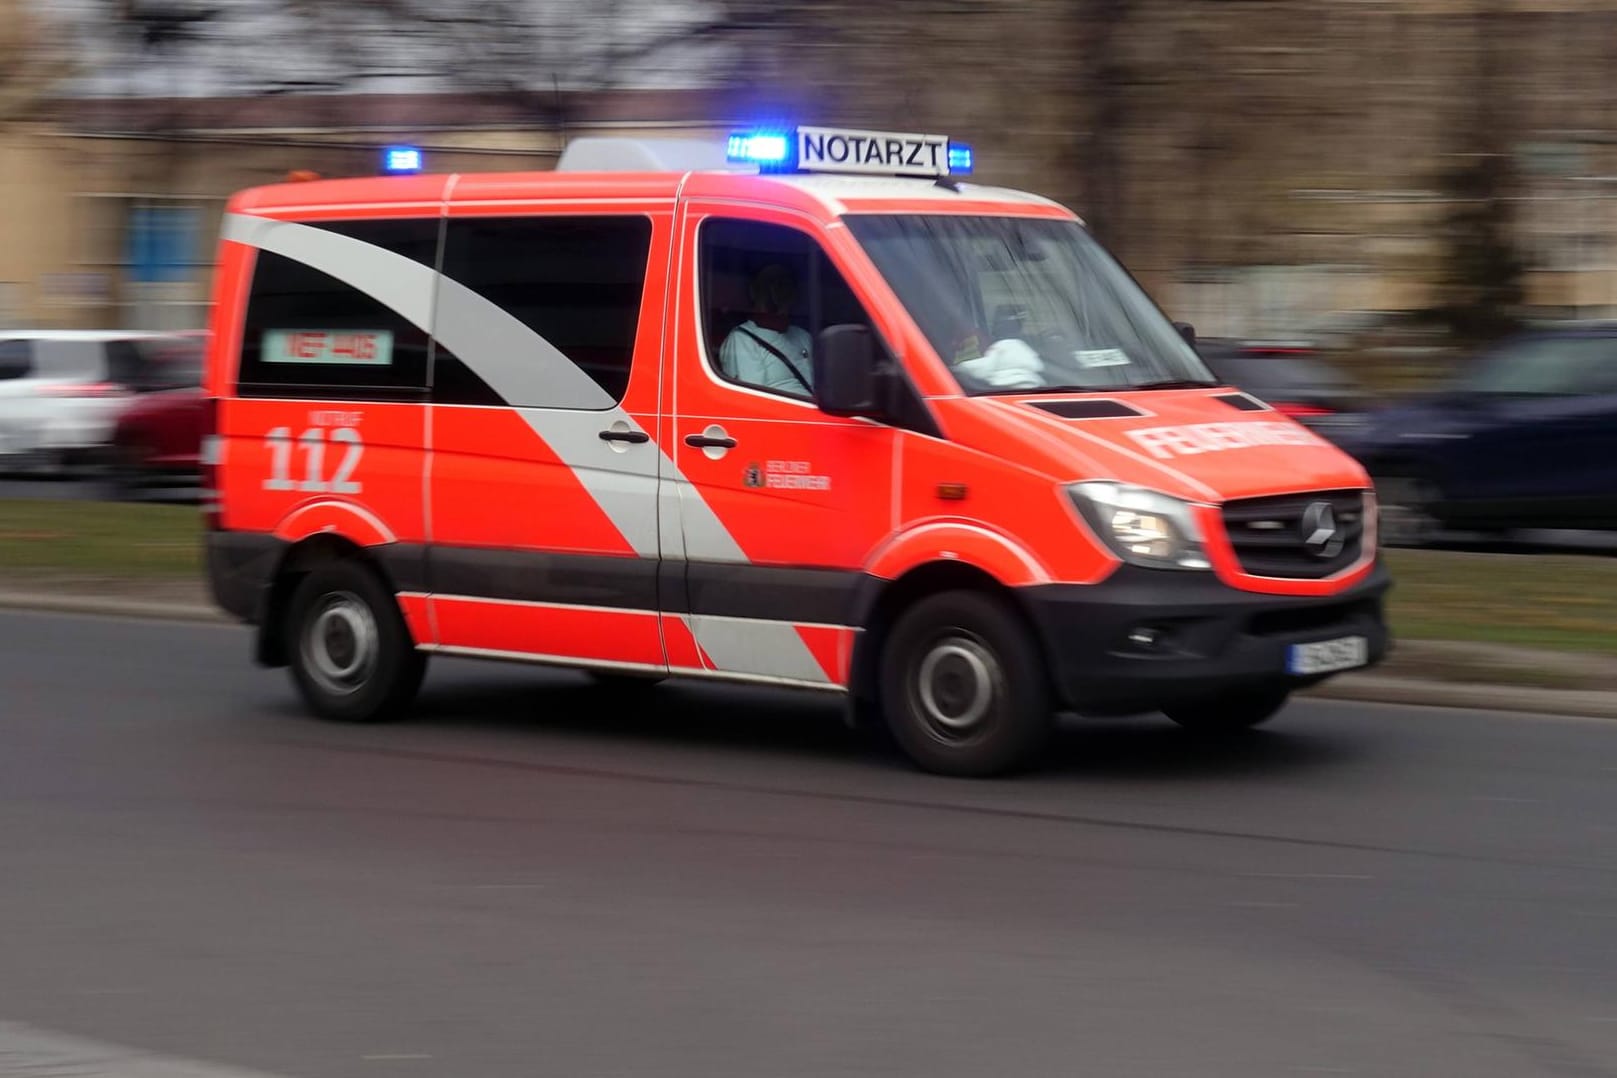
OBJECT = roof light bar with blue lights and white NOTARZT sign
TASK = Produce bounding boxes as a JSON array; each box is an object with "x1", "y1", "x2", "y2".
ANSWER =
[{"x1": 726, "y1": 128, "x2": 972, "y2": 179}]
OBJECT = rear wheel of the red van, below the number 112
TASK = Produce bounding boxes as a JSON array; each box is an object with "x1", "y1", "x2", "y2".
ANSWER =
[{"x1": 285, "y1": 561, "x2": 427, "y2": 722}]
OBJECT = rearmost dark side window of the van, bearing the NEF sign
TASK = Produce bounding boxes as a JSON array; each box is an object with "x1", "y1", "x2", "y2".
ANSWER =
[{"x1": 238, "y1": 220, "x2": 438, "y2": 401}]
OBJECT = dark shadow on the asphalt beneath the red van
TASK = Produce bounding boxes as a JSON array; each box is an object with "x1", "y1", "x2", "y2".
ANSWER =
[{"x1": 370, "y1": 672, "x2": 1373, "y2": 782}]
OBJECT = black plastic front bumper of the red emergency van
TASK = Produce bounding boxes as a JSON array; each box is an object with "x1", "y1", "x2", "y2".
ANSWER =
[{"x1": 1020, "y1": 564, "x2": 1391, "y2": 714}]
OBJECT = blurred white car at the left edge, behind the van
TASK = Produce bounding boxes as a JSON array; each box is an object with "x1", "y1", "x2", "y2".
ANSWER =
[{"x1": 0, "y1": 330, "x2": 201, "y2": 472}]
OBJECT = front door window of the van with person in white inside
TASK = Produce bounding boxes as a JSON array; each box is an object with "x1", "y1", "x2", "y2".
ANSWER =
[{"x1": 697, "y1": 218, "x2": 872, "y2": 401}]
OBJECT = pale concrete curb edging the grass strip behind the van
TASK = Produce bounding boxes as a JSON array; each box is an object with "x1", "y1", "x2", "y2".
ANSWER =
[{"x1": 0, "y1": 590, "x2": 1617, "y2": 719}]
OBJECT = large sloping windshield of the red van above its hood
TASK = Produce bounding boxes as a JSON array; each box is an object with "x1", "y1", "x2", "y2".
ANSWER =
[{"x1": 846, "y1": 215, "x2": 1214, "y2": 394}]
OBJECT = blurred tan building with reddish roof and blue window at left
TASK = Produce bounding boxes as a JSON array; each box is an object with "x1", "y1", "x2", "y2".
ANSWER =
[{"x1": 0, "y1": 91, "x2": 733, "y2": 328}]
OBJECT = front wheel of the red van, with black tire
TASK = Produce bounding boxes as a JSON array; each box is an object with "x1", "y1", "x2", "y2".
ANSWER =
[{"x1": 878, "y1": 592, "x2": 1054, "y2": 777}]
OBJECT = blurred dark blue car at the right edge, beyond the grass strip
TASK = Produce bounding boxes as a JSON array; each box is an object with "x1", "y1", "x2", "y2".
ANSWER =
[{"x1": 1345, "y1": 323, "x2": 1617, "y2": 545}]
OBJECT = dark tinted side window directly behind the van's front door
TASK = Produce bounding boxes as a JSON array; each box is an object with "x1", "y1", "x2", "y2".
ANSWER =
[{"x1": 432, "y1": 217, "x2": 652, "y2": 407}]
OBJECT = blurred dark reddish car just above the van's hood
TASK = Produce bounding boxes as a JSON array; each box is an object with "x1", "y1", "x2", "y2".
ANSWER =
[{"x1": 1197, "y1": 338, "x2": 1368, "y2": 438}]
